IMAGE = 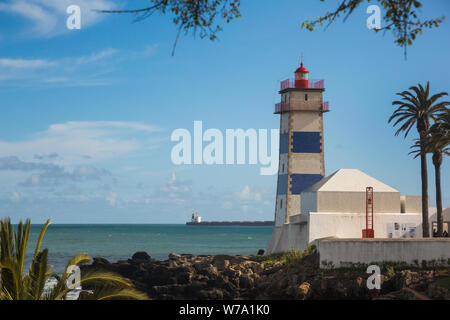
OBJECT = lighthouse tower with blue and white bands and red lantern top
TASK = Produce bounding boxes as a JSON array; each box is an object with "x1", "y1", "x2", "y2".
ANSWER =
[{"x1": 275, "y1": 61, "x2": 329, "y2": 227}]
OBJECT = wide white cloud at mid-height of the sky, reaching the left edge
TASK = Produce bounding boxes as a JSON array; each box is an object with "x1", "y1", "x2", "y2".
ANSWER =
[{"x1": 0, "y1": 121, "x2": 160, "y2": 165}]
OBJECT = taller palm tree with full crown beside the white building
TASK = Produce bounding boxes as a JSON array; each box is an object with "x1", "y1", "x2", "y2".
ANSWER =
[{"x1": 388, "y1": 82, "x2": 450, "y2": 238}]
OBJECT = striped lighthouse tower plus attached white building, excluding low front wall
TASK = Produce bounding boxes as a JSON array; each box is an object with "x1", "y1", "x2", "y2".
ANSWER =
[{"x1": 266, "y1": 64, "x2": 450, "y2": 257}]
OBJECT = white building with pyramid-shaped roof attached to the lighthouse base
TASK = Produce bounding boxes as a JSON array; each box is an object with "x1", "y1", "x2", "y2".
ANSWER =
[{"x1": 267, "y1": 169, "x2": 450, "y2": 254}]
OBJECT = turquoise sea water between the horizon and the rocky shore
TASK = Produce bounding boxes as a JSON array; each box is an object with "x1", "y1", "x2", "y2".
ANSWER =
[{"x1": 26, "y1": 224, "x2": 273, "y2": 272}]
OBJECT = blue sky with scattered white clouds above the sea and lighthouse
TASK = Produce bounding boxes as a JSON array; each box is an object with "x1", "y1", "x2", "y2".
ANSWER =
[{"x1": 0, "y1": 0, "x2": 450, "y2": 223}]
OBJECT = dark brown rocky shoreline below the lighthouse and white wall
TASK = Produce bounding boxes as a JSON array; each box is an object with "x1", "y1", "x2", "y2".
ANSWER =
[{"x1": 82, "y1": 252, "x2": 450, "y2": 300}]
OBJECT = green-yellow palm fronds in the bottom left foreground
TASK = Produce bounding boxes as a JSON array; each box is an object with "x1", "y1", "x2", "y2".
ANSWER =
[{"x1": 0, "y1": 218, "x2": 147, "y2": 300}]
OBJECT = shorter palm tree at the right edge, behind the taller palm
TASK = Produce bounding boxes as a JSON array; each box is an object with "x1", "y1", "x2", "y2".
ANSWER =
[{"x1": 410, "y1": 109, "x2": 450, "y2": 237}]
